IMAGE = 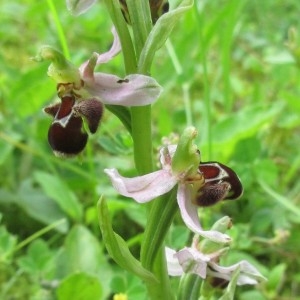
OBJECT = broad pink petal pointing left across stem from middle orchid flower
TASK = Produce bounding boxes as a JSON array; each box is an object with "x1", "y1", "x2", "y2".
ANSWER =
[{"x1": 104, "y1": 169, "x2": 177, "y2": 203}]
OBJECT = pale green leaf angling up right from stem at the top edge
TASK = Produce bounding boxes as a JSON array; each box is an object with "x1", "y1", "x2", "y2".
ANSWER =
[{"x1": 138, "y1": 0, "x2": 194, "y2": 73}]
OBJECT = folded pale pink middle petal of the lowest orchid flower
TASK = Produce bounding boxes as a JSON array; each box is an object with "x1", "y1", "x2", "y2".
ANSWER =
[{"x1": 175, "y1": 247, "x2": 210, "y2": 279}]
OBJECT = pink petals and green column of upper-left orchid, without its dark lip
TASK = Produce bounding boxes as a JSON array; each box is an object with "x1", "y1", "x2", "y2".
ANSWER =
[{"x1": 34, "y1": 27, "x2": 162, "y2": 106}]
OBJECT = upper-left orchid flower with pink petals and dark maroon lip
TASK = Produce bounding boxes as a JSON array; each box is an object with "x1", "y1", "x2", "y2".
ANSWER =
[{"x1": 34, "y1": 28, "x2": 161, "y2": 156}]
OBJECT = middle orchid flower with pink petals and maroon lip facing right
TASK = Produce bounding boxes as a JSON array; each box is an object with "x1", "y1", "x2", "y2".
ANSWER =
[{"x1": 104, "y1": 127, "x2": 243, "y2": 243}]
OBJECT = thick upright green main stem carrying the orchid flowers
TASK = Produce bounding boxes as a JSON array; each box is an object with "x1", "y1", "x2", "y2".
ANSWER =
[{"x1": 105, "y1": 0, "x2": 176, "y2": 300}]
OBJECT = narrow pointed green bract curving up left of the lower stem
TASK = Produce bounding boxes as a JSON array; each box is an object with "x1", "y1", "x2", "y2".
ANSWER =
[{"x1": 98, "y1": 197, "x2": 155, "y2": 283}]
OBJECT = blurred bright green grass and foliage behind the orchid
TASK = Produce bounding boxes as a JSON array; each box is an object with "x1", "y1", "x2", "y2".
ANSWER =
[{"x1": 0, "y1": 0, "x2": 300, "y2": 300}]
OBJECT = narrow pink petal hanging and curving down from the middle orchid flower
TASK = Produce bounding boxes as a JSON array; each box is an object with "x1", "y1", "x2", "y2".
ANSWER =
[{"x1": 177, "y1": 184, "x2": 231, "y2": 243}]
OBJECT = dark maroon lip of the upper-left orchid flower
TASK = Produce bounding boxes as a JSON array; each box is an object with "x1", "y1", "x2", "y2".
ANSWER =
[{"x1": 44, "y1": 93, "x2": 103, "y2": 157}]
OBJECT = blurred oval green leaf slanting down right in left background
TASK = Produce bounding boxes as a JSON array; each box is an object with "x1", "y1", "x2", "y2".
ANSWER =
[{"x1": 34, "y1": 171, "x2": 83, "y2": 221}]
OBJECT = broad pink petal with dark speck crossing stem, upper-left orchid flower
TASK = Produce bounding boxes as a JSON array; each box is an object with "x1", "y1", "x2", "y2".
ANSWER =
[{"x1": 82, "y1": 72, "x2": 161, "y2": 106}]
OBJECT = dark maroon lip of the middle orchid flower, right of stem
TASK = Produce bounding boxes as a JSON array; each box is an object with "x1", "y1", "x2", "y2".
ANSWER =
[{"x1": 196, "y1": 161, "x2": 243, "y2": 206}]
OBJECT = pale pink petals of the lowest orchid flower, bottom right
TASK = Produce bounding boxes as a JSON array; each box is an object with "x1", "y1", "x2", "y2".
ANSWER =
[{"x1": 165, "y1": 241, "x2": 265, "y2": 285}]
